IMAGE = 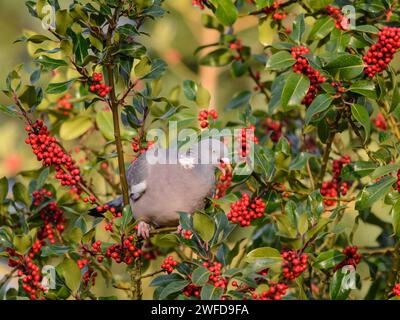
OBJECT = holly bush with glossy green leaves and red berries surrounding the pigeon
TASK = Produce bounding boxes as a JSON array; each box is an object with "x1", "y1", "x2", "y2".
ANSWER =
[{"x1": 0, "y1": 0, "x2": 400, "y2": 300}]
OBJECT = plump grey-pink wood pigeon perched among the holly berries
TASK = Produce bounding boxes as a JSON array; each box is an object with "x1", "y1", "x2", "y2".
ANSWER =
[{"x1": 90, "y1": 138, "x2": 230, "y2": 239}]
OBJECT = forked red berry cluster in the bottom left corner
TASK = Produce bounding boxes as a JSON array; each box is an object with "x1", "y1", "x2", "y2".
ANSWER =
[{"x1": 6, "y1": 245, "x2": 46, "y2": 300}]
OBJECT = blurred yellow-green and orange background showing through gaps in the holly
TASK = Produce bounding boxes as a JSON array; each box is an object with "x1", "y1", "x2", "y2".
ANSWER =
[{"x1": 0, "y1": 0, "x2": 390, "y2": 298}]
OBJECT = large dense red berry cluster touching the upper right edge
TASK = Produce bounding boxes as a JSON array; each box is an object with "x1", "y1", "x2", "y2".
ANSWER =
[{"x1": 363, "y1": 27, "x2": 400, "y2": 78}]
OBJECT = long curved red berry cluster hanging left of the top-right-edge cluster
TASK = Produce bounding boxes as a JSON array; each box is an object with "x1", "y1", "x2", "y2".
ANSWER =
[{"x1": 291, "y1": 46, "x2": 326, "y2": 106}]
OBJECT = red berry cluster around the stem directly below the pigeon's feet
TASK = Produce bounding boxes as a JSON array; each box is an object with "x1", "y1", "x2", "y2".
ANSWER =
[{"x1": 106, "y1": 235, "x2": 142, "y2": 265}]
